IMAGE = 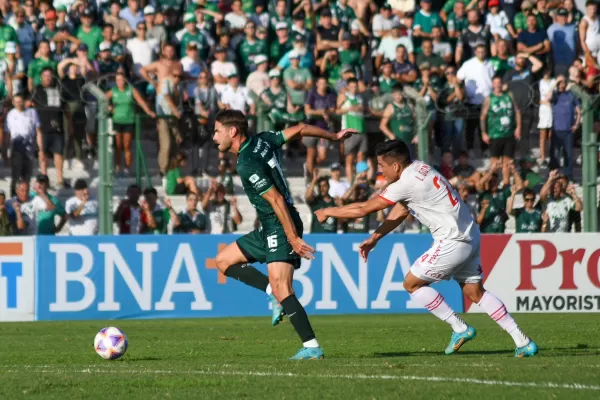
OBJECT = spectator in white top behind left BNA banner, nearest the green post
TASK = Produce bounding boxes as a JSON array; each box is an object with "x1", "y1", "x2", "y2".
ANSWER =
[{"x1": 65, "y1": 179, "x2": 98, "y2": 236}]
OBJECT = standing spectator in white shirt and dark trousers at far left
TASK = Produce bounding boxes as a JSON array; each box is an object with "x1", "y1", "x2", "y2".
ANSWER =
[{"x1": 4, "y1": 95, "x2": 40, "y2": 196}]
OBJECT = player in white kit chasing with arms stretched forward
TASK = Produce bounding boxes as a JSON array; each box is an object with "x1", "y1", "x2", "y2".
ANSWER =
[{"x1": 315, "y1": 140, "x2": 538, "y2": 357}]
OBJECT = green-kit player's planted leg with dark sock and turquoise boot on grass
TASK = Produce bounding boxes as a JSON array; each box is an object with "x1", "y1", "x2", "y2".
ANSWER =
[{"x1": 268, "y1": 261, "x2": 324, "y2": 360}]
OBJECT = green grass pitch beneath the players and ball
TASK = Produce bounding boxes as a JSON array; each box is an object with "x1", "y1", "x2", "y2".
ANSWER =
[{"x1": 0, "y1": 314, "x2": 600, "y2": 400}]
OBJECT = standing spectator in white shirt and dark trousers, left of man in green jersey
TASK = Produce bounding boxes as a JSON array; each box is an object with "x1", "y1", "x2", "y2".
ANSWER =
[{"x1": 456, "y1": 44, "x2": 495, "y2": 155}]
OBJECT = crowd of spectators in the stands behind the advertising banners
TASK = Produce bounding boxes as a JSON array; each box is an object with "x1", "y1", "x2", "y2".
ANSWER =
[{"x1": 0, "y1": 0, "x2": 600, "y2": 235}]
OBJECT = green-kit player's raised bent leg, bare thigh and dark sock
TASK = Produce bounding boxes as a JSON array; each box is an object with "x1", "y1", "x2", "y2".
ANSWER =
[{"x1": 217, "y1": 241, "x2": 269, "y2": 292}]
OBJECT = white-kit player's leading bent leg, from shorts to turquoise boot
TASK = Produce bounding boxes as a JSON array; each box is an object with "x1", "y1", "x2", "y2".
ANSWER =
[{"x1": 404, "y1": 240, "x2": 477, "y2": 354}]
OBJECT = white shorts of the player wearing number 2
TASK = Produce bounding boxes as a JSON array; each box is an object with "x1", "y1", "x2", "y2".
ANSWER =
[{"x1": 410, "y1": 238, "x2": 483, "y2": 283}]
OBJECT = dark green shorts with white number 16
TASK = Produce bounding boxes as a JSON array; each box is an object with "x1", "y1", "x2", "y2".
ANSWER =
[{"x1": 236, "y1": 214, "x2": 304, "y2": 269}]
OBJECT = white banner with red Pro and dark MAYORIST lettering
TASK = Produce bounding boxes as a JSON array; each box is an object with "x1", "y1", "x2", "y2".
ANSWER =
[{"x1": 465, "y1": 233, "x2": 600, "y2": 312}]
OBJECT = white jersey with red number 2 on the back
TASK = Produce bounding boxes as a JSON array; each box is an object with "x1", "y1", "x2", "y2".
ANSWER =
[{"x1": 379, "y1": 161, "x2": 480, "y2": 242}]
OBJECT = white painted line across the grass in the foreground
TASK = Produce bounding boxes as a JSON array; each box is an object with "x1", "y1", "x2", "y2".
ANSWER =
[{"x1": 4, "y1": 368, "x2": 600, "y2": 391}]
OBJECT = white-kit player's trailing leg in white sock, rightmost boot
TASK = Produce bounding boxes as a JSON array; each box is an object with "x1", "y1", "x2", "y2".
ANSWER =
[{"x1": 459, "y1": 282, "x2": 538, "y2": 357}]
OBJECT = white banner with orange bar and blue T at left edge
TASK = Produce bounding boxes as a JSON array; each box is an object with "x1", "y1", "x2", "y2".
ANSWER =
[{"x1": 0, "y1": 237, "x2": 35, "y2": 322}]
